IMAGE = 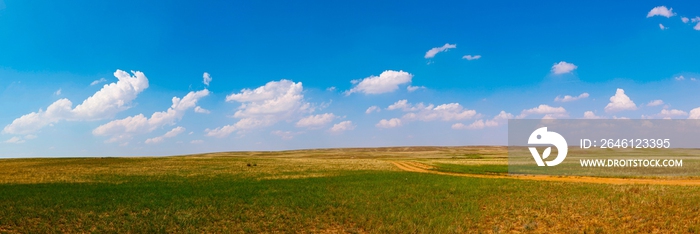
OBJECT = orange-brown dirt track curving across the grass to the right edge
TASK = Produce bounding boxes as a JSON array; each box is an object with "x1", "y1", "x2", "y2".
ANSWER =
[{"x1": 391, "y1": 161, "x2": 700, "y2": 186}]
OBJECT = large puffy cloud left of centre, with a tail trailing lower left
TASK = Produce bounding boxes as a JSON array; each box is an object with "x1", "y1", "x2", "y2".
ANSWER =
[{"x1": 205, "y1": 80, "x2": 312, "y2": 137}]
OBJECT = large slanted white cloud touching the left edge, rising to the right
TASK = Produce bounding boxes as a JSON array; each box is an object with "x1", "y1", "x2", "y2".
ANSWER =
[{"x1": 3, "y1": 70, "x2": 148, "y2": 134}]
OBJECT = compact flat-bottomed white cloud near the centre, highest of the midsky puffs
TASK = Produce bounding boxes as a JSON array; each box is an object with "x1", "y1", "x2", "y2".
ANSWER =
[{"x1": 345, "y1": 70, "x2": 413, "y2": 95}]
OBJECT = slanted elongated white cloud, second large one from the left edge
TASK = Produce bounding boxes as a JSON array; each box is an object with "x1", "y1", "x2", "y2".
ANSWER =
[{"x1": 92, "y1": 89, "x2": 209, "y2": 142}]
